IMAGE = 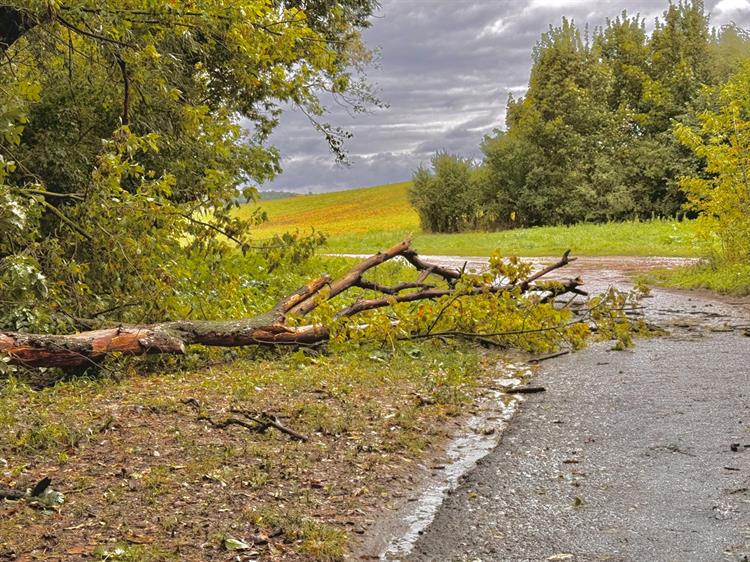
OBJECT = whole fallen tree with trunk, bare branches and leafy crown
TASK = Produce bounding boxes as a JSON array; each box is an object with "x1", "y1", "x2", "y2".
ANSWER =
[{"x1": 0, "y1": 236, "x2": 631, "y2": 368}]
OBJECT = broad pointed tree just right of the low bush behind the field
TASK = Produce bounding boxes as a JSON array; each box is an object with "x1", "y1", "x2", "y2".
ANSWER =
[{"x1": 483, "y1": 19, "x2": 617, "y2": 226}]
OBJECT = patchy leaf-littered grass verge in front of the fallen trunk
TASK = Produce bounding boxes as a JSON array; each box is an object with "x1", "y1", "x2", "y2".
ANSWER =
[{"x1": 0, "y1": 342, "x2": 512, "y2": 562}]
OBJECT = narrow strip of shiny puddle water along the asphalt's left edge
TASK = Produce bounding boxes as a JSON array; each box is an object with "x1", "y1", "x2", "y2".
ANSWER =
[{"x1": 378, "y1": 363, "x2": 533, "y2": 562}]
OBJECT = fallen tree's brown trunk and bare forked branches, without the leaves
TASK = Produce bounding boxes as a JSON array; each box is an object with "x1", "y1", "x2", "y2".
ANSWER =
[{"x1": 0, "y1": 240, "x2": 586, "y2": 368}]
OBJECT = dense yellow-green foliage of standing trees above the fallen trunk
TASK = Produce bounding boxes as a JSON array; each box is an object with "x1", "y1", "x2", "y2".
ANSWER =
[{"x1": 0, "y1": 0, "x2": 376, "y2": 330}]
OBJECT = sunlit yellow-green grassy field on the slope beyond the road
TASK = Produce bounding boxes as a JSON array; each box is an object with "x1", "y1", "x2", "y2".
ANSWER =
[{"x1": 240, "y1": 182, "x2": 698, "y2": 257}]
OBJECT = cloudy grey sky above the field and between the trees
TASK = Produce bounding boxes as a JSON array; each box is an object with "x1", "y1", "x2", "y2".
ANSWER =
[{"x1": 262, "y1": 0, "x2": 750, "y2": 193}]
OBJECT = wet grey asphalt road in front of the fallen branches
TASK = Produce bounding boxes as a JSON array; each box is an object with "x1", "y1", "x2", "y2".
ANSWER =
[{"x1": 402, "y1": 264, "x2": 750, "y2": 562}]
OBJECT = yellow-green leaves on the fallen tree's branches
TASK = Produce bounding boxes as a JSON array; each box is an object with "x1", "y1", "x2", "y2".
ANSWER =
[{"x1": 290, "y1": 252, "x2": 642, "y2": 353}]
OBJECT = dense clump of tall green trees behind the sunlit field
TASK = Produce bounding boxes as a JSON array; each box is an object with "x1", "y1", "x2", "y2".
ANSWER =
[{"x1": 410, "y1": 1, "x2": 750, "y2": 232}]
